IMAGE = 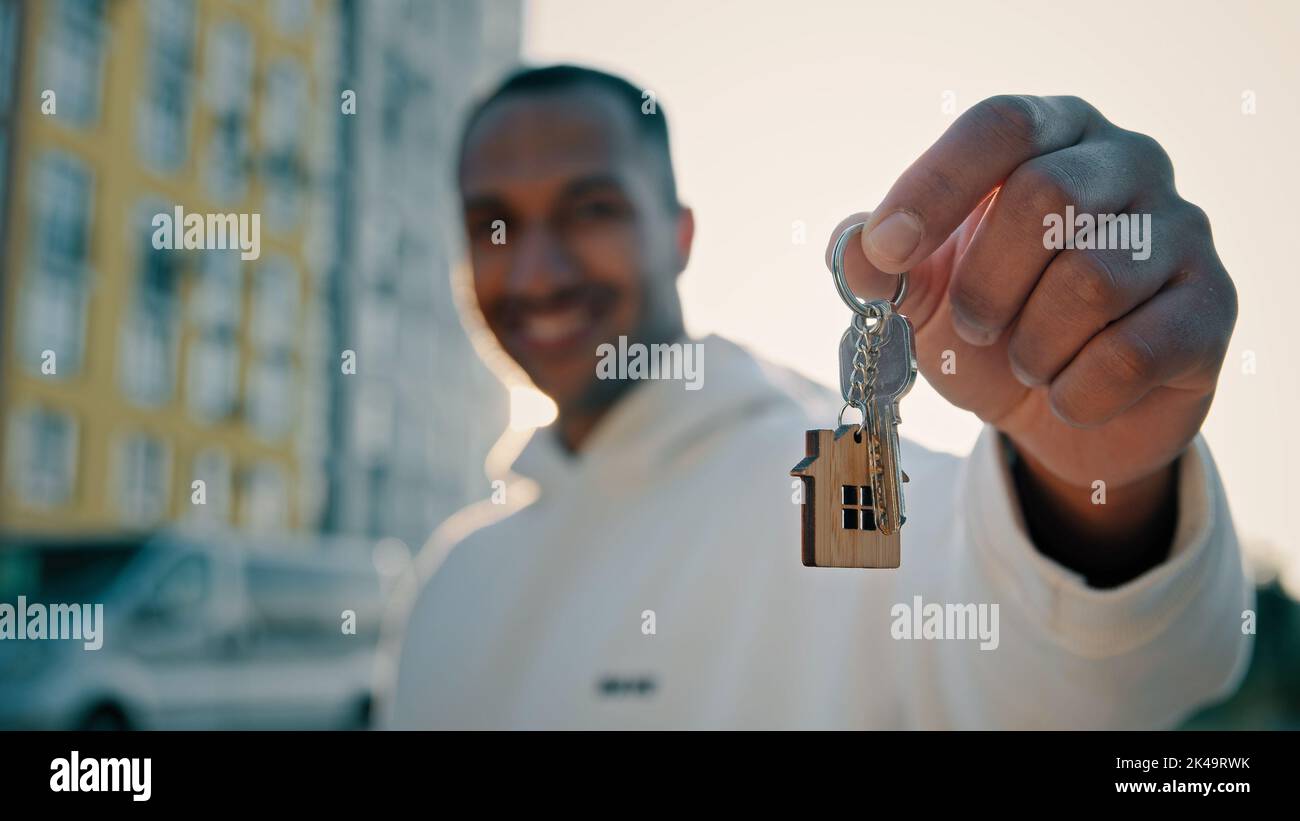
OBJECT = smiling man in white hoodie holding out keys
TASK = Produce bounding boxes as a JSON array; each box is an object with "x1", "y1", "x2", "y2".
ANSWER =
[{"x1": 384, "y1": 66, "x2": 1252, "y2": 727}]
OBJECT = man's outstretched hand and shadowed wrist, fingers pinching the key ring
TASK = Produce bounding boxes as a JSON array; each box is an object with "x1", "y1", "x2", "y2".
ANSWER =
[{"x1": 828, "y1": 96, "x2": 1236, "y2": 583}]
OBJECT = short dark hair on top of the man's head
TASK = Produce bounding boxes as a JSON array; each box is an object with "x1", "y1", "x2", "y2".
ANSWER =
[{"x1": 456, "y1": 64, "x2": 679, "y2": 208}]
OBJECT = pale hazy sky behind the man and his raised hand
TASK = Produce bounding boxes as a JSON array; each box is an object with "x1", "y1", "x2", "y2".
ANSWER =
[{"x1": 524, "y1": 0, "x2": 1300, "y2": 579}]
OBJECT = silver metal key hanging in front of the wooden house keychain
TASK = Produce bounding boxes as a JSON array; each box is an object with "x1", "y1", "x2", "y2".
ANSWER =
[{"x1": 867, "y1": 313, "x2": 917, "y2": 535}]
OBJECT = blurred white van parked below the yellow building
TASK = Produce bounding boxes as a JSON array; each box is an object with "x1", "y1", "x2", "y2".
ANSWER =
[{"x1": 0, "y1": 531, "x2": 387, "y2": 729}]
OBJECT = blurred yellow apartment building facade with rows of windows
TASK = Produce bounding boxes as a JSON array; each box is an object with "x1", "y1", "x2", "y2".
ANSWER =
[{"x1": 0, "y1": 0, "x2": 339, "y2": 531}]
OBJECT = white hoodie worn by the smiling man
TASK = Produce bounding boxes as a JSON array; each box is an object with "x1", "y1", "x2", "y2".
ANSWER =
[{"x1": 381, "y1": 336, "x2": 1253, "y2": 729}]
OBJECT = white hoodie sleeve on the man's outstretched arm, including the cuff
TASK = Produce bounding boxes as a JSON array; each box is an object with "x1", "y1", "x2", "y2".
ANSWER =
[{"x1": 905, "y1": 427, "x2": 1255, "y2": 729}]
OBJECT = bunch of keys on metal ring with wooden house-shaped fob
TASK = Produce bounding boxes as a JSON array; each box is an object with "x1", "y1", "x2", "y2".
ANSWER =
[{"x1": 790, "y1": 222, "x2": 917, "y2": 568}]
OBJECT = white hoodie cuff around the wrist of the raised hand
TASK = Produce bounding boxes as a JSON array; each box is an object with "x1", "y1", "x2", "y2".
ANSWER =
[{"x1": 958, "y1": 426, "x2": 1222, "y2": 657}]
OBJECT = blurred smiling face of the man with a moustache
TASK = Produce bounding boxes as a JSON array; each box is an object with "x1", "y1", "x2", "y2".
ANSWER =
[{"x1": 460, "y1": 86, "x2": 692, "y2": 412}]
